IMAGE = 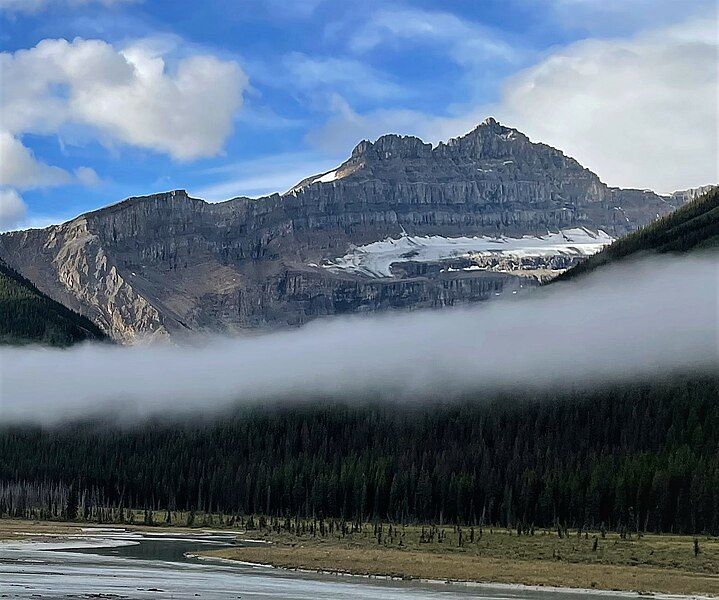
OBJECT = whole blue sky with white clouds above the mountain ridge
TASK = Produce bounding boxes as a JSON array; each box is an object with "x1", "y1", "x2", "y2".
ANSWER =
[{"x1": 0, "y1": 0, "x2": 717, "y2": 229}]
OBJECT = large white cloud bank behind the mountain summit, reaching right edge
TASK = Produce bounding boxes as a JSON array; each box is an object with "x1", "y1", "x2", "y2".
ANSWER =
[{"x1": 308, "y1": 18, "x2": 719, "y2": 192}]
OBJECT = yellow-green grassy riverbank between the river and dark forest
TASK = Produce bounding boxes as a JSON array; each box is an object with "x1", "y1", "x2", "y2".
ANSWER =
[{"x1": 0, "y1": 513, "x2": 719, "y2": 597}]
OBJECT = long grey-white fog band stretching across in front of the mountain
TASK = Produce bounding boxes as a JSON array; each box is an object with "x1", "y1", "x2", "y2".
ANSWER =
[{"x1": 0, "y1": 255, "x2": 719, "y2": 424}]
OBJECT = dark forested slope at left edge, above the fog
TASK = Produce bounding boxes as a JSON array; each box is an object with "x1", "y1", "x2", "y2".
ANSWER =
[{"x1": 0, "y1": 260, "x2": 105, "y2": 346}]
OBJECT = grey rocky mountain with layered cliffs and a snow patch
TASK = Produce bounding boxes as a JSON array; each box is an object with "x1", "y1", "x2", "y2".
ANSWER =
[{"x1": 0, "y1": 118, "x2": 680, "y2": 342}]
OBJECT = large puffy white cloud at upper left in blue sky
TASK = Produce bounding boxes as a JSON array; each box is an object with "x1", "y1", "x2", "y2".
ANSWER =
[{"x1": 0, "y1": 38, "x2": 247, "y2": 160}]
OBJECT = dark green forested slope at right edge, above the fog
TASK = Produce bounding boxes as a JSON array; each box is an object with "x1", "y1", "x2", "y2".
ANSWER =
[{"x1": 554, "y1": 187, "x2": 719, "y2": 281}]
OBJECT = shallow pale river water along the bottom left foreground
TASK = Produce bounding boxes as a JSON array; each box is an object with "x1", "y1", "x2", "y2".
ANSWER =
[{"x1": 0, "y1": 528, "x2": 696, "y2": 600}]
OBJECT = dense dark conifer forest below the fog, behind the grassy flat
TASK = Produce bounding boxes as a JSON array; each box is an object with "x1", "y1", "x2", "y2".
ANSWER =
[{"x1": 0, "y1": 376, "x2": 719, "y2": 535}]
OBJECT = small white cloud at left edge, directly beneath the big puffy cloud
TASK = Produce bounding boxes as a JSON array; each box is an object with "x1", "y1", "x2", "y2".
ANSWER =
[{"x1": 0, "y1": 131, "x2": 72, "y2": 190}]
